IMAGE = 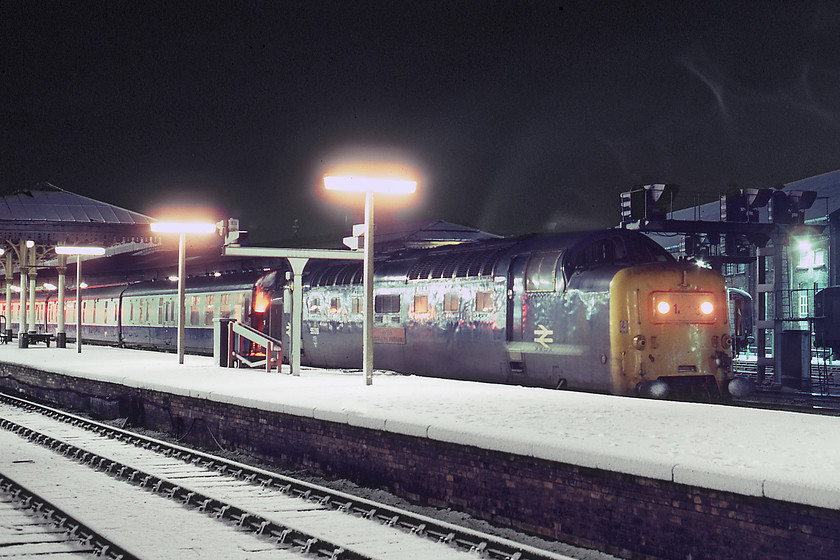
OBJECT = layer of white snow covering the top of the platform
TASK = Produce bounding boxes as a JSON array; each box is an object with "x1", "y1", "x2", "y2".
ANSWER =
[{"x1": 0, "y1": 345, "x2": 840, "y2": 509}]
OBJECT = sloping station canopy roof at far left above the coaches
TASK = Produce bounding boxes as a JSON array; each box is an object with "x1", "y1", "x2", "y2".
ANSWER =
[{"x1": 0, "y1": 183, "x2": 154, "y2": 246}]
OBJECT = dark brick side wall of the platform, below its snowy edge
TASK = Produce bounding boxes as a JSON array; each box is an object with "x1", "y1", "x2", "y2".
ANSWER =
[{"x1": 0, "y1": 364, "x2": 840, "y2": 560}]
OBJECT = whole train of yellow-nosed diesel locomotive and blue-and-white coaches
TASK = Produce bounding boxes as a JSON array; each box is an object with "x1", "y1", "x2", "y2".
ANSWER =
[{"x1": 3, "y1": 229, "x2": 751, "y2": 399}]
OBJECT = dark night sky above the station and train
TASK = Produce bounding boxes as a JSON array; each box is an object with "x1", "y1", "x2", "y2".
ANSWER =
[{"x1": 0, "y1": 0, "x2": 840, "y2": 240}]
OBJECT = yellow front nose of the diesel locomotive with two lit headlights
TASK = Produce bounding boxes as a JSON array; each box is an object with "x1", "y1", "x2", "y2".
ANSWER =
[{"x1": 610, "y1": 263, "x2": 732, "y2": 398}]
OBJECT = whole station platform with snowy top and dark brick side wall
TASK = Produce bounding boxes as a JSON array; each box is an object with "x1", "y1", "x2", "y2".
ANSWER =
[{"x1": 0, "y1": 345, "x2": 840, "y2": 559}]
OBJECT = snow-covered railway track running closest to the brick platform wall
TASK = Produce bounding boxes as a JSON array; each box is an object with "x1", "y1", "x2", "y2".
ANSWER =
[{"x1": 0, "y1": 394, "x2": 592, "y2": 560}]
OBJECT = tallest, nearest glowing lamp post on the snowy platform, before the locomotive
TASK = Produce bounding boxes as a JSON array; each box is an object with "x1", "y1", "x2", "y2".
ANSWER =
[{"x1": 324, "y1": 170, "x2": 417, "y2": 385}]
